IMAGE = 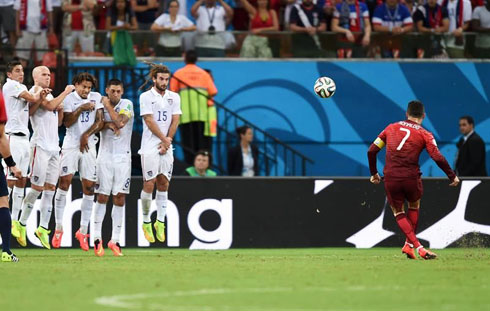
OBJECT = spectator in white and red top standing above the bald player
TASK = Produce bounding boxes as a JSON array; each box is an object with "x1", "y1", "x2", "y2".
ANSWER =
[{"x1": 14, "y1": 0, "x2": 53, "y2": 67}]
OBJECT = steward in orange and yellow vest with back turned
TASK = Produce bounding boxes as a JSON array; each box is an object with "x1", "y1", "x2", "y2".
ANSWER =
[{"x1": 170, "y1": 50, "x2": 218, "y2": 165}]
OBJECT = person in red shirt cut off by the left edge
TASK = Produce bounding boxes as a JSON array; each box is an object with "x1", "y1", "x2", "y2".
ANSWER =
[{"x1": 0, "y1": 92, "x2": 22, "y2": 262}]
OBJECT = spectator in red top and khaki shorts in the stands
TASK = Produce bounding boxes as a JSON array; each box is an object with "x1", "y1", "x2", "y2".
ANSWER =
[{"x1": 240, "y1": 0, "x2": 279, "y2": 58}]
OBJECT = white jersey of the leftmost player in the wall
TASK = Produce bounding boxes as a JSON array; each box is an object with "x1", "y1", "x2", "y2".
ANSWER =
[{"x1": 2, "y1": 78, "x2": 29, "y2": 136}]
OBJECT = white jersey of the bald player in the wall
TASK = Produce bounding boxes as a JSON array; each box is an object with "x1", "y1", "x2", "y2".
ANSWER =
[{"x1": 29, "y1": 86, "x2": 60, "y2": 151}]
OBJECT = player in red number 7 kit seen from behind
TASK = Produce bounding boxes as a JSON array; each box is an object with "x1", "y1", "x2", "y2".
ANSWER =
[{"x1": 368, "y1": 100, "x2": 459, "y2": 259}]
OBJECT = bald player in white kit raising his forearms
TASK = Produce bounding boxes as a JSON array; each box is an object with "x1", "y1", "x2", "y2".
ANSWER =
[{"x1": 17, "y1": 66, "x2": 75, "y2": 249}]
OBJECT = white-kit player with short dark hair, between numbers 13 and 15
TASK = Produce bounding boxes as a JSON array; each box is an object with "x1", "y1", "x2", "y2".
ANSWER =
[{"x1": 93, "y1": 79, "x2": 134, "y2": 256}]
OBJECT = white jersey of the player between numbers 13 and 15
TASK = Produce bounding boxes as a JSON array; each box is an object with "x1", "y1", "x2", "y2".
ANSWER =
[{"x1": 98, "y1": 99, "x2": 134, "y2": 159}]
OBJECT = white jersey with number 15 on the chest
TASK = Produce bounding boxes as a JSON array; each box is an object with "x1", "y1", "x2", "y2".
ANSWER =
[{"x1": 138, "y1": 88, "x2": 182, "y2": 154}]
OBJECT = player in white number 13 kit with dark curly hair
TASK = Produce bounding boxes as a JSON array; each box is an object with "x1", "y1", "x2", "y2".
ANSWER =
[{"x1": 51, "y1": 72, "x2": 104, "y2": 251}]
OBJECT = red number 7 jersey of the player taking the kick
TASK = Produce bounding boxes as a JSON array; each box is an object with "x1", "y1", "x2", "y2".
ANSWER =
[{"x1": 368, "y1": 120, "x2": 456, "y2": 180}]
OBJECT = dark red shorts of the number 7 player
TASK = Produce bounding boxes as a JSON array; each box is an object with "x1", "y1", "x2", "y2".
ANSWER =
[{"x1": 384, "y1": 178, "x2": 424, "y2": 209}]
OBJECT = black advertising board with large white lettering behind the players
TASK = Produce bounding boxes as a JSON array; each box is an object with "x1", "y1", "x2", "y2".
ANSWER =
[{"x1": 4, "y1": 177, "x2": 490, "y2": 249}]
